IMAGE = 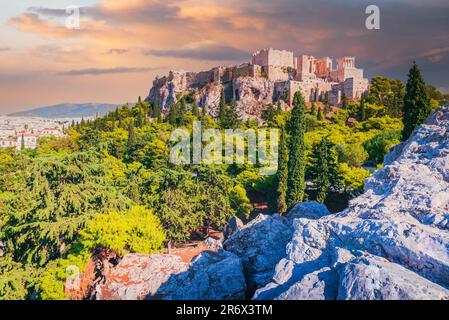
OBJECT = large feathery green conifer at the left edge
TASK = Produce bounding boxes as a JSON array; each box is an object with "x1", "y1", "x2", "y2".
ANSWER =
[{"x1": 0, "y1": 152, "x2": 130, "y2": 266}]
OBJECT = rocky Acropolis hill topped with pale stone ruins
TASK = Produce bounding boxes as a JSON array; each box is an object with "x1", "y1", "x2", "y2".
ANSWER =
[{"x1": 147, "y1": 48, "x2": 369, "y2": 118}]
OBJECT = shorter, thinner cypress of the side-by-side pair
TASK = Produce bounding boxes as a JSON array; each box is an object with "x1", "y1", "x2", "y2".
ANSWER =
[{"x1": 276, "y1": 129, "x2": 288, "y2": 214}]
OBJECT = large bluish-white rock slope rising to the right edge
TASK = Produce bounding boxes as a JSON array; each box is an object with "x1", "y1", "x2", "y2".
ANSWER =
[{"x1": 254, "y1": 106, "x2": 449, "y2": 299}]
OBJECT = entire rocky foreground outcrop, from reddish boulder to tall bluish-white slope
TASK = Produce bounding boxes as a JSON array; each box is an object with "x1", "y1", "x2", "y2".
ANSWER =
[{"x1": 91, "y1": 106, "x2": 449, "y2": 299}]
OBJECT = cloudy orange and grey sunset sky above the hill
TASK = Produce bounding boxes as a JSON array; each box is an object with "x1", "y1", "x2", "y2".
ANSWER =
[{"x1": 0, "y1": 0, "x2": 449, "y2": 114}]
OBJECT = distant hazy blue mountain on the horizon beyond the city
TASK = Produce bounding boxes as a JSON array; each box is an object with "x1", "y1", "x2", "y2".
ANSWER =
[{"x1": 9, "y1": 103, "x2": 121, "y2": 118}]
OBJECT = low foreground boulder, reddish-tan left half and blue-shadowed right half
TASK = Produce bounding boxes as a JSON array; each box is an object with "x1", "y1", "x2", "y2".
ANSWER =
[{"x1": 95, "y1": 250, "x2": 246, "y2": 300}]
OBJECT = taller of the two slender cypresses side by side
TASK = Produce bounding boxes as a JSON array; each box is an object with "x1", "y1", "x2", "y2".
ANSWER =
[{"x1": 287, "y1": 92, "x2": 306, "y2": 207}]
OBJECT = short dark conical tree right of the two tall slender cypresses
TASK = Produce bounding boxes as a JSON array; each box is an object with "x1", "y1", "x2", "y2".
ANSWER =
[{"x1": 310, "y1": 137, "x2": 339, "y2": 203}]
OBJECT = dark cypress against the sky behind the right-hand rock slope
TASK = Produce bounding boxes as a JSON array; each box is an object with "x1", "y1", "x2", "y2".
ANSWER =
[{"x1": 402, "y1": 62, "x2": 432, "y2": 141}]
